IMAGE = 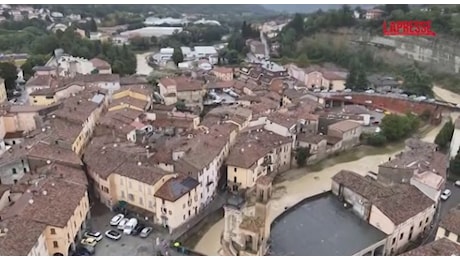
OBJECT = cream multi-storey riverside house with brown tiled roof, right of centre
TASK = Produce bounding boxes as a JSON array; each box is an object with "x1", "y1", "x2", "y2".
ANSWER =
[{"x1": 226, "y1": 128, "x2": 292, "y2": 191}]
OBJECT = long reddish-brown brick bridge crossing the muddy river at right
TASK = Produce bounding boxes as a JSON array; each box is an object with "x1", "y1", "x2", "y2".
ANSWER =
[{"x1": 319, "y1": 93, "x2": 460, "y2": 123}]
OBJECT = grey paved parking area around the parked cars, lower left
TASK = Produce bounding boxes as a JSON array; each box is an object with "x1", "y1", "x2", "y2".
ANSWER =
[{"x1": 90, "y1": 205, "x2": 164, "y2": 256}]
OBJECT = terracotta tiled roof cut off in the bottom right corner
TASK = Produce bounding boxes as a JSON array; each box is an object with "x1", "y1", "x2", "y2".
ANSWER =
[{"x1": 401, "y1": 238, "x2": 460, "y2": 256}]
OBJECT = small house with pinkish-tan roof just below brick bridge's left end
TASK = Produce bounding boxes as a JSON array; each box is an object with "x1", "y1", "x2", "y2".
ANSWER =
[{"x1": 327, "y1": 120, "x2": 362, "y2": 149}]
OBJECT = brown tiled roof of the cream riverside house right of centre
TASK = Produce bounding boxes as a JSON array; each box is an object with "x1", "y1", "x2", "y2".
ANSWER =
[{"x1": 226, "y1": 129, "x2": 292, "y2": 169}]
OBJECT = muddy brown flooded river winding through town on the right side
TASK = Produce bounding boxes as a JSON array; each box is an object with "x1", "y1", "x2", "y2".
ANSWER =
[{"x1": 195, "y1": 87, "x2": 460, "y2": 255}]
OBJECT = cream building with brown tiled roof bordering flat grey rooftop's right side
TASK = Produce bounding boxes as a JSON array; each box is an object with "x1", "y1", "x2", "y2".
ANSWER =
[{"x1": 332, "y1": 170, "x2": 436, "y2": 255}]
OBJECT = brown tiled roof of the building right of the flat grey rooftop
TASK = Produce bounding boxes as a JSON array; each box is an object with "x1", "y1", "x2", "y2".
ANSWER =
[{"x1": 332, "y1": 170, "x2": 435, "y2": 225}]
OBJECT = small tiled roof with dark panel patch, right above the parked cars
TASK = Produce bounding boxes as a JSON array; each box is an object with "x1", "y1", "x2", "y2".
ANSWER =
[{"x1": 155, "y1": 175, "x2": 199, "y2": 202}]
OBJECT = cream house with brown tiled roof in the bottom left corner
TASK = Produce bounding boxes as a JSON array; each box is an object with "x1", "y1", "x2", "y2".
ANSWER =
[{"x1": 0, "y1": 163, "x2": 89, "y2": 256}]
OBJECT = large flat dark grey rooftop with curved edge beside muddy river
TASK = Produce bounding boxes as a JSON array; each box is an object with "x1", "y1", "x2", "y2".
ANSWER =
[{"x1": 271, "y1": 193, "x2": 386, "y2": 256}]
